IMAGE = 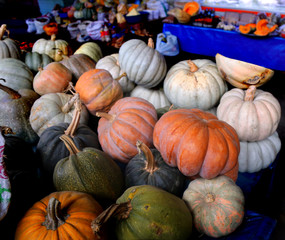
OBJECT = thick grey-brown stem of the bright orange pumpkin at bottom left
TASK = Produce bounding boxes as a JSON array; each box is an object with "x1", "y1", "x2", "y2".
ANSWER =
[{"x1": 43, "y1": 198, "x2": 68, "y2": 230}]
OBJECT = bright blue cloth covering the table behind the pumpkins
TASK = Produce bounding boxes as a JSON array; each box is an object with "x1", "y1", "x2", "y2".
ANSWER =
[{"x1": 163, "y1": 23, "x2": 285, "y2": 71}]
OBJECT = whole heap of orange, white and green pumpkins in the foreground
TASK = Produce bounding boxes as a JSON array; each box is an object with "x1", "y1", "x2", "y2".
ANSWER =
[{"x1": 0, "y1": 22, "x2": 281, "y2": 240}]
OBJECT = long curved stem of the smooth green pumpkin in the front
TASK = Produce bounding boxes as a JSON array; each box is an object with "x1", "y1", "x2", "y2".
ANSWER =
[{"x1": 91, "y1": 201, "x2": 132, "y2": 238}]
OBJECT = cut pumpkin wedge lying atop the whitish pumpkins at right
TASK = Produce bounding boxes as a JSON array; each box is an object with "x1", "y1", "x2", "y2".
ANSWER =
[{"x1": 216, "y1": 53, "x2": 274, "y2": 89}]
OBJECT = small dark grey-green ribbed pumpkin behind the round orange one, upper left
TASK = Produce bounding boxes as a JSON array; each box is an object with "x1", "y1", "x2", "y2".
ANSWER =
[{"x1": 24, "y1": 52, "x2": 53, "y2": 74}]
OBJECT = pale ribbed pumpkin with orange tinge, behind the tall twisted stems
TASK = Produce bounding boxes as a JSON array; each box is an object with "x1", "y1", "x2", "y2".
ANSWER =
[{"x1": 29, "y1": 93, "x2": 89, "y2": 136}]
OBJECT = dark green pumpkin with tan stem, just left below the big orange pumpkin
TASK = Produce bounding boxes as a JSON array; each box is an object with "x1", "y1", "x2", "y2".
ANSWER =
[{"x1": 125, "y1": 141, "x2": 185, "y2": 196}]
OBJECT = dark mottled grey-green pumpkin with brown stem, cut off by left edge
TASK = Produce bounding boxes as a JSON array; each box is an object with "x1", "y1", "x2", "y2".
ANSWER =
[{"x1": 0, "y1": 84, "x2": 39, "y2": 144}]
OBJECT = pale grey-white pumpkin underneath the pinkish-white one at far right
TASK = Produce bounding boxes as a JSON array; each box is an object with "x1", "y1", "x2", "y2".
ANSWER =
[{"x1": 238, "y1": 131, "x2": 281, "y2": 173}]
